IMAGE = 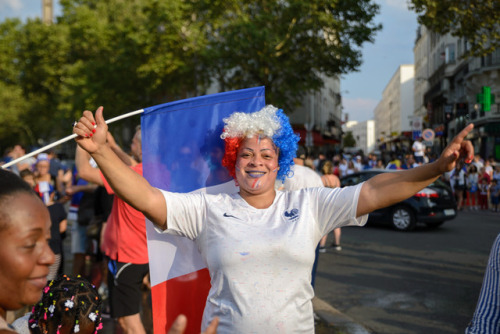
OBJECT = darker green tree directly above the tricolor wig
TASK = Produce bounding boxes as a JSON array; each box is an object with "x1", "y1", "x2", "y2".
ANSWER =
[{"x1": 198, "y1": 0, "x2": 381, "y2": 111}]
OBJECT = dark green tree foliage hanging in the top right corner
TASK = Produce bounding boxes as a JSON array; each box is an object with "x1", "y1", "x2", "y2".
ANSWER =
[{"x1": 409, "y1": 0, "x2": 500, "y2": 56}]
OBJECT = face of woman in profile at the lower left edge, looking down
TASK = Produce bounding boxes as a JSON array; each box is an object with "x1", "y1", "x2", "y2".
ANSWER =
[{"x1": 0, "y1": 192, "x2": 54, "y2": 310}]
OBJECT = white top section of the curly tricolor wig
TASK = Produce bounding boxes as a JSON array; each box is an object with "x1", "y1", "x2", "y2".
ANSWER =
[{"x1": 221, "y1": 104, "x2": 281, "y2": 139}]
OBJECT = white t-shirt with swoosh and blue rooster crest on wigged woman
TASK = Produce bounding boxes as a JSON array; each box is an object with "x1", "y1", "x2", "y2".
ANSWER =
[{"x1": 162, "y1": 184, "x2": 368, "y2": 333}]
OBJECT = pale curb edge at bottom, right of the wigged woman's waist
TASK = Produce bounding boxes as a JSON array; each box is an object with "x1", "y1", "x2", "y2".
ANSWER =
[{"x1": 312, "y1": 297, "x2": 372, "y2": 334}]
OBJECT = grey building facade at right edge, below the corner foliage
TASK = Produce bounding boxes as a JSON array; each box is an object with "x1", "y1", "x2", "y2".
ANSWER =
[{"x1": 414, "y1": 27, "x2": 500, "y2": 160}]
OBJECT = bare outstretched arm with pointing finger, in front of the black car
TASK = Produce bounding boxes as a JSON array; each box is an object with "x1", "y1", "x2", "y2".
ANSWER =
[{"x1": 356, "y1": 124, "x2": 474, "y2": 217}]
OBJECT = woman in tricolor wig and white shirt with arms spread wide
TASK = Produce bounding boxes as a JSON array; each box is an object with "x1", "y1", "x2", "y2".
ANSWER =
[{"x1": 73, "y1": 105, "x2": 474, "y2": 333}]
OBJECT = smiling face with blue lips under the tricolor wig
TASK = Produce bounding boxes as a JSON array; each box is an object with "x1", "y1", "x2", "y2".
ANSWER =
[{"x1": 235, "y1": 136, "x2": 279, "y2": 194}]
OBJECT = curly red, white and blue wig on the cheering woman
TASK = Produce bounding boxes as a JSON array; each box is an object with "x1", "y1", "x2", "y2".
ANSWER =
[{"x1": 221, "y1": 105, "x2": 300, "y2": 182}]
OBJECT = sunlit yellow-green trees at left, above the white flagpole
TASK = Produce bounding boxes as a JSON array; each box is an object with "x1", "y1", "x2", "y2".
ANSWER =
[{"x1": 0, "y1": 0, "x2": 209, "y2": 149}]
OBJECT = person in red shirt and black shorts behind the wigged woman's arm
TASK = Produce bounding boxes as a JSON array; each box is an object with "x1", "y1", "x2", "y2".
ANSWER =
[{"x1": 75, "y1": 127, "x2": 149, "y2": 334}]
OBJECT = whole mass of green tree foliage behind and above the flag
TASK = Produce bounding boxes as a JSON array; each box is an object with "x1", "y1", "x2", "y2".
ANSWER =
[{"x1": 0, "y1": 0, "x2": 381, "y2": 151}]
